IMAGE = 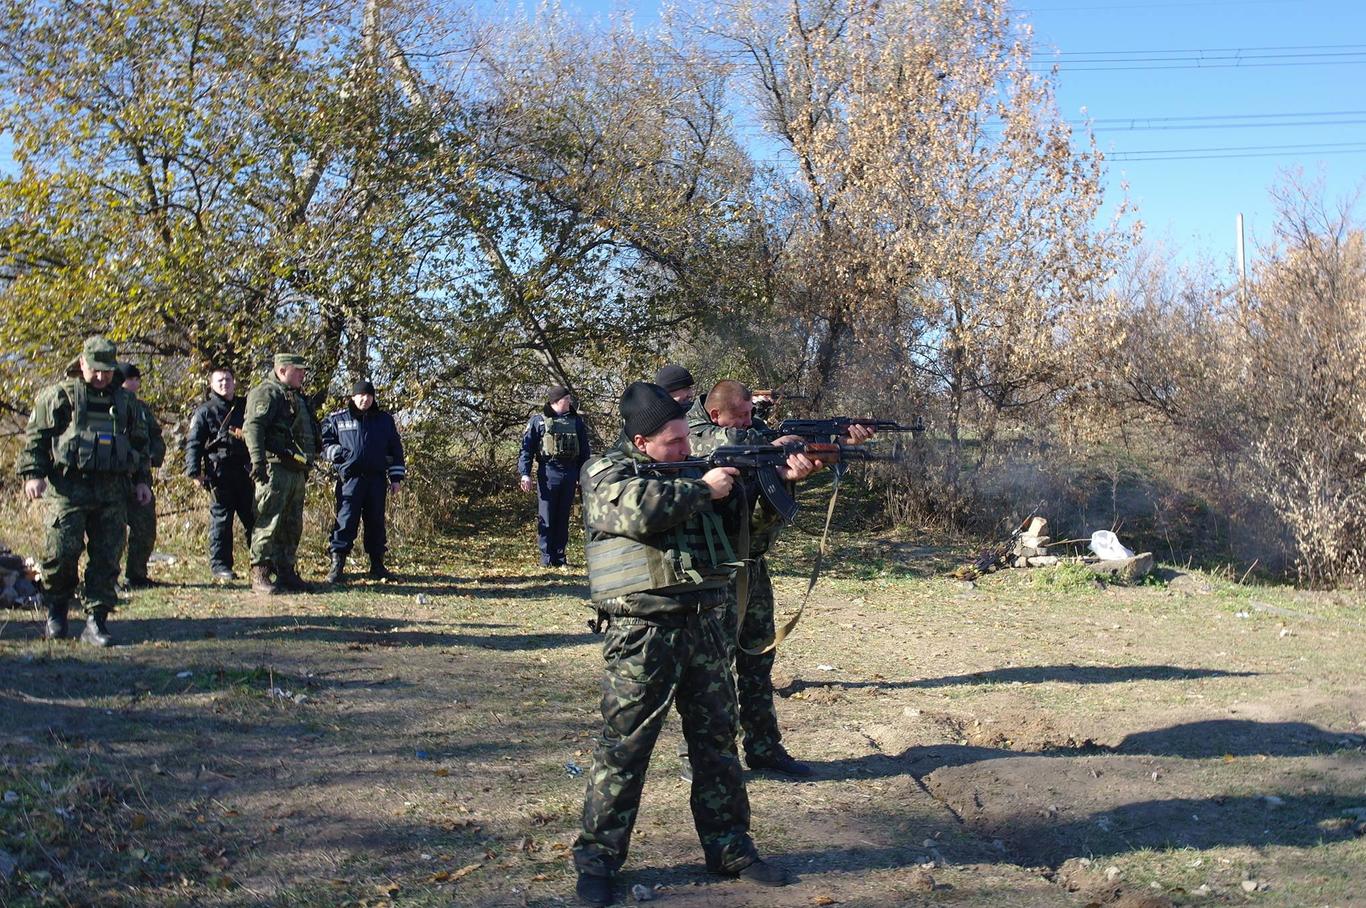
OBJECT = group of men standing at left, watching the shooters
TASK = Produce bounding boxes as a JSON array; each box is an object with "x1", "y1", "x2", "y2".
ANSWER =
[{"x1": 19, "y1": 336, "x2": 406, "y2": 646}]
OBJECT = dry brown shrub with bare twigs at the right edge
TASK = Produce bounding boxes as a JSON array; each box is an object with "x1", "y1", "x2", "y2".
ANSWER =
[{"x1": 1086, "y1": 182, "x2": 1366, "y2": 586}]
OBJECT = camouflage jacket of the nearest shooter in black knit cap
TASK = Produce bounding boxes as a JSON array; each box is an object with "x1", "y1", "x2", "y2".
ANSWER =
[{"x1": 579, "y1": 436, "x2": 736, "y2": 619}]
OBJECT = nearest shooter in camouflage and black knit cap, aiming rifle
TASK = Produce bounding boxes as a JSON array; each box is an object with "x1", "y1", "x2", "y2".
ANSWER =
[{"x1": 574, "y1": 382, "x2": 788, "y2": 905}]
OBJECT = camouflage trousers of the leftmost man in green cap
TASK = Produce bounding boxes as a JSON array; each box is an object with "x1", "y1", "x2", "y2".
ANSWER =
[{"x1": 42, "y1": 475, "x2": 131, "y2": 612}]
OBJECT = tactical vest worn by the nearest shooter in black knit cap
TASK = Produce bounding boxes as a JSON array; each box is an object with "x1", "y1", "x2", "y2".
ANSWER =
[{"x1": 583, "y1": 460, "x2": 738, "y2": 602}]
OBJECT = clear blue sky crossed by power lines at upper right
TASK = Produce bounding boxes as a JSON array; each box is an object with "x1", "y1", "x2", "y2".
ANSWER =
[{"x1": 566, "y1": 0, "x2": 1366, "y2": 266}]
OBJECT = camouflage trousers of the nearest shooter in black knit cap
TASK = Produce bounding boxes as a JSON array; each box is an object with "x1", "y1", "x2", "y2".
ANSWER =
[{"x1": 574, "y1": 609, "x2": 757, "y2": 875}]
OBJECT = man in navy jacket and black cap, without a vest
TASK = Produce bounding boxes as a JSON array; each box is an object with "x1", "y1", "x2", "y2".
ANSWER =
[{"x1": 322, "y1": 381, "x2": 407, "y2": 583}]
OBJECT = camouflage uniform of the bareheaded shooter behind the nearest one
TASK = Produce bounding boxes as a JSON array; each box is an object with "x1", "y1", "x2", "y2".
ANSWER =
[{"x1": 687, "y1": 396, "x2": 790, "y2": 766}]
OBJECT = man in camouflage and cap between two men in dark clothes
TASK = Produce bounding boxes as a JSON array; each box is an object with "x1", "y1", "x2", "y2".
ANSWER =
[{"x1": 242, "y1": 354, "x2": 322, "y2": 594}]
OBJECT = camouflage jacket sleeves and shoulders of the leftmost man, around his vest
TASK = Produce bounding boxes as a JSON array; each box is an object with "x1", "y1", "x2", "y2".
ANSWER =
[{"x1": 19, "y1": 378, "x2": 151, "y2": 485}]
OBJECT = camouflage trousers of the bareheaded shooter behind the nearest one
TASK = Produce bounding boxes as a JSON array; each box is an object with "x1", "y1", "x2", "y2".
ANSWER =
[{"x1": 725, "y1": 556, "x2": 783, "y2": 758}]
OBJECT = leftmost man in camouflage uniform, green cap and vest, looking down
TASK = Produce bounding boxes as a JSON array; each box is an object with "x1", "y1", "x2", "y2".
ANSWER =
[{"x1": 19, "y1": 336, "x2": 152, "y2": 646}]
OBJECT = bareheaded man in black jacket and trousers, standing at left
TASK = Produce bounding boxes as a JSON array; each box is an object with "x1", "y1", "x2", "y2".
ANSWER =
[{"x1": 184, "y1": 366, "x2": 255, "y2": 580}]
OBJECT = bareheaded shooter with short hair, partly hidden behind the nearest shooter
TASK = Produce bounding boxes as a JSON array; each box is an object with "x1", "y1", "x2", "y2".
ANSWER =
[{"x1": 684, "y1": 380, "x2": 873, "y2": 776}]
